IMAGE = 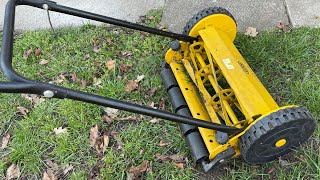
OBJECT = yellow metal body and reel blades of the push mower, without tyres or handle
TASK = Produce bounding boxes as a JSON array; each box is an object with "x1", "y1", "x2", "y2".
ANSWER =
[{"x1": 165, "y1": 14, "x2": 292, "y2": 160}]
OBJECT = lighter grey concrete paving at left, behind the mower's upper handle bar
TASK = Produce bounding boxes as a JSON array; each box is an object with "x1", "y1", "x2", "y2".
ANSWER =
[{"x1": 0, "y1": 0, "x2": 165, "y2": 30}]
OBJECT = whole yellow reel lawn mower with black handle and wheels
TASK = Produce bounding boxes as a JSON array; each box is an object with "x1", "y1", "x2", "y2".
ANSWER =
[{"x1": 0, "y1": 0, "x2": 316, "y2": 172}]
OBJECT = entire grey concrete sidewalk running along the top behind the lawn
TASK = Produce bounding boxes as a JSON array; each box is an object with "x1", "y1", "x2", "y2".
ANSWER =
[{"x1": 0, "y1": 0, "x2": 320, "y2": 32}]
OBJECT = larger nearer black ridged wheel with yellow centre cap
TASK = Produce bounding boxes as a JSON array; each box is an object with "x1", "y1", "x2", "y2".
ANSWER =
[{"x1": 239, "y1": 107, "x2": 316, "y2": 164}]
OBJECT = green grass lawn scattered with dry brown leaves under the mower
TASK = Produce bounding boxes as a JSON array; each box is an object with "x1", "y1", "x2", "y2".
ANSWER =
[{"x1": 0, "y1": 11, "x2": 320, "y2": 179}]
